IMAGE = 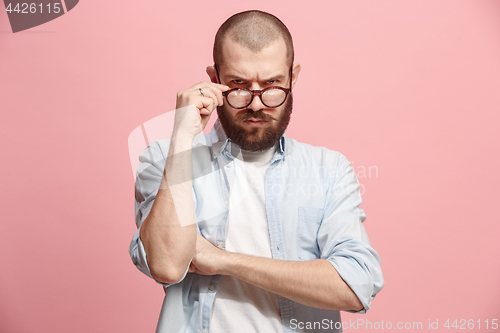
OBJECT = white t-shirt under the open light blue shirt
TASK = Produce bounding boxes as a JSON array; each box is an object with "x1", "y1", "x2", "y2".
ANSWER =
[{"x1": 210, "y1": 143, "x2": 283, "y2": 333}]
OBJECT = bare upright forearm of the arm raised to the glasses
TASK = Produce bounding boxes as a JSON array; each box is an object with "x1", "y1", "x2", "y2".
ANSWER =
[{"x1": 140, "y1": 134, "x2": 196, "y2": 283}]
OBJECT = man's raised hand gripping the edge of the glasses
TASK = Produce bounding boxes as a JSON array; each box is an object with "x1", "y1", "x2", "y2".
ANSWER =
[{"x1": 173, "y1": 82, "x2": 229, "y2": 139}]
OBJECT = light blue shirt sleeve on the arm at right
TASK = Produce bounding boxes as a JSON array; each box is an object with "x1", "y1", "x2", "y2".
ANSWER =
[{"x1": 317, "y1": 153, "x2": 384, "y2": 313}]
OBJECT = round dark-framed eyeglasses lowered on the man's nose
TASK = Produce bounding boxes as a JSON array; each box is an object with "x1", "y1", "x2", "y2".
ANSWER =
[{"x1": 222, "y1": 87, "x2": 290, "y2": 109}]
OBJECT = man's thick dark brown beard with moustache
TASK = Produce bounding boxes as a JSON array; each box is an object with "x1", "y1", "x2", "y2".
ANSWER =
[{"x1": 217, "y1": 92, "x2": 293, "y2": 151}]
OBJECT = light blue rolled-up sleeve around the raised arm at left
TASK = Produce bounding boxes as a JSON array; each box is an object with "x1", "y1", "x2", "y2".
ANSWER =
[{"x1": 129, "y1": 140, "x2": 196, "y2": 287}]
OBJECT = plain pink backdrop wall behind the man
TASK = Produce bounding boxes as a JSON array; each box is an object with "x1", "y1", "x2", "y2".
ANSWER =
[{"x1": 0, "y1": 0, "x2": 500, "y2": 333}]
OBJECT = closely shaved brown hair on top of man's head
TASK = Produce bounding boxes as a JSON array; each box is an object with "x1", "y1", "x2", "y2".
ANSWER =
[{"x1": 214, "y1": 10, "x2": 294, "y2": 68}]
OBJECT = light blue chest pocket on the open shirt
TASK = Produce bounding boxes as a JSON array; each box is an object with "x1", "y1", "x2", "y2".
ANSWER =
[{"x1": 297, "y1": 207, "x2": 323, "y2": 260}]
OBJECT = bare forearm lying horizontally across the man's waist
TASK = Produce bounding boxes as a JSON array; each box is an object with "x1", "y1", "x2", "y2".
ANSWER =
[{"x1": 221, "y1": 252, "x2": 363, "y2": 311}]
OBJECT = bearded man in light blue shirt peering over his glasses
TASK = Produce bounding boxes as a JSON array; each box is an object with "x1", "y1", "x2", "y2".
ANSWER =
[{"x1": 130, "y1": 11, "x2": 384, "y2": 333}]
